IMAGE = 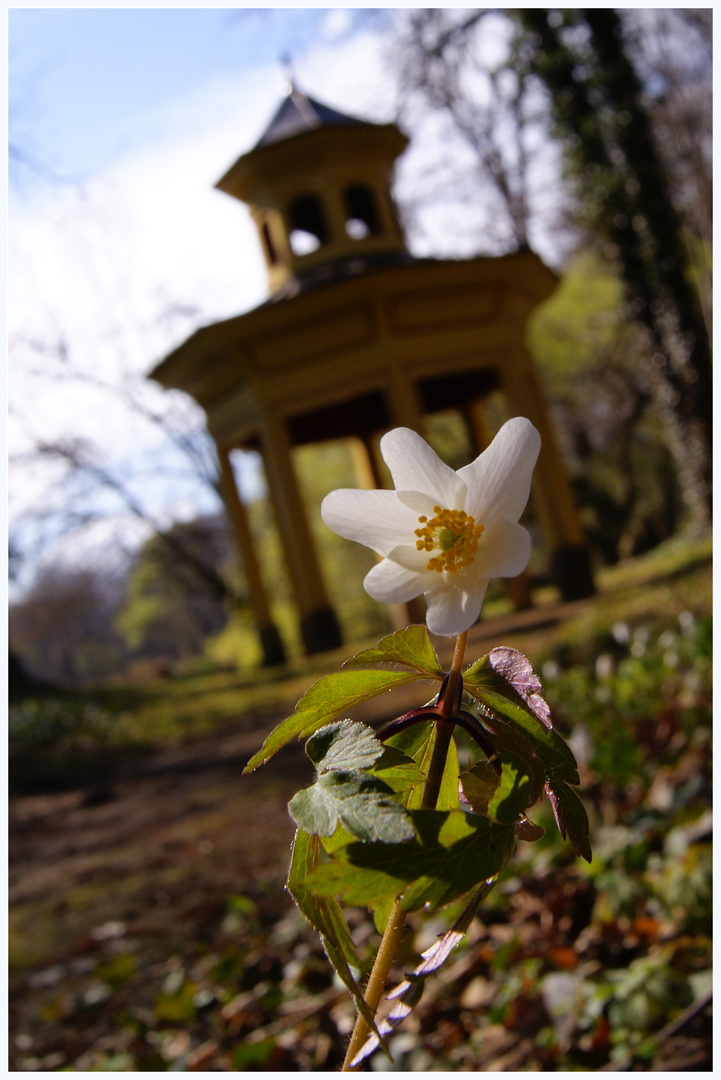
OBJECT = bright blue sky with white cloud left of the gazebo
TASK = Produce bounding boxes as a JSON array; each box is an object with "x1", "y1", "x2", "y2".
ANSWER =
[{"x1": 8, "y1": 9, "x2": 397, "y2": 591}]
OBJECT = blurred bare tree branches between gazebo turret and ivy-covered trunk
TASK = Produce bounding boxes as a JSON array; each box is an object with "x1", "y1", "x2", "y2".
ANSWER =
[{"x1": 387, "y1": 9, "x2": 569, "y2": 256}]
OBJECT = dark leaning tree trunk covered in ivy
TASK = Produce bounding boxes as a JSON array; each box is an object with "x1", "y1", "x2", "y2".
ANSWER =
[{"x1": 518, "y1": 9, "x2": 712, "y2": 516}]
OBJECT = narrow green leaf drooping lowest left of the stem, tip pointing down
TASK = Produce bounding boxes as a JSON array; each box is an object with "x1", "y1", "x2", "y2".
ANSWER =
[{"x1": 287, "y1": 829, "x2": 380, "y2": 1037}]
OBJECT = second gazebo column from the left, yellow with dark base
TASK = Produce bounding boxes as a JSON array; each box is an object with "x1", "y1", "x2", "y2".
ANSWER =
[{"x1": 260, "y1": 413, "x2": 341, "y2": 654}]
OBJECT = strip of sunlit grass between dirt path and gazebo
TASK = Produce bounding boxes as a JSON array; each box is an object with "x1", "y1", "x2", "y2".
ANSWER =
[{"x1": 10, "y1": 537, "x2": 711, "y2": 793}]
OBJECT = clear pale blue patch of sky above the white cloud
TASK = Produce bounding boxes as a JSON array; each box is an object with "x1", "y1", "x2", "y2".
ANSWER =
[{"x1": 9, "y1": 8, "x2": 360, "y2": 184}]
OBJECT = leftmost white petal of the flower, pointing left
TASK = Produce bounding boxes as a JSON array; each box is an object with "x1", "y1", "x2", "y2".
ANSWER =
[{"x1": 321, "y1": 487, "x2": 418, "y2": 555}]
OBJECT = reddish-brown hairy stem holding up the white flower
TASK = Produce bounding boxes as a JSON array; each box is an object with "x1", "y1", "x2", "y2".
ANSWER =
[{"x1": 341, "y1": 631, "x2": 468, "y2": 1072}]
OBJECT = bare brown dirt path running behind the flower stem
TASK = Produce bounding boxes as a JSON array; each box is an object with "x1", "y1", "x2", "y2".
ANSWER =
[{"x1": 9, "y1": 605, "x2": 705, "y2": 1070}]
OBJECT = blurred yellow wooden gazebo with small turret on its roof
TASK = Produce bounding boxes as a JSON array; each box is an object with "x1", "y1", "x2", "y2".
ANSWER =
[{"x1": 151, "y1": 89, "x2": 594, "y2": 662}]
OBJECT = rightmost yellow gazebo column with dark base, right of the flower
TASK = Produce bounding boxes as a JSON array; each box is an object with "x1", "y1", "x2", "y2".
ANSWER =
[{"x1": 501, "y1": 349, "x2": 596, "y2": 600}]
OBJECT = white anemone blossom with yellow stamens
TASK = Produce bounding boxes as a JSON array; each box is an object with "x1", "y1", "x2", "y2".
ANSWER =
[{"x1": 321, "y1": 417, "x2": 541, "y2": 637}]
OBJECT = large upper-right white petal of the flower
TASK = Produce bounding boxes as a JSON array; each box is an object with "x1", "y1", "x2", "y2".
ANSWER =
[{"x1": 459, "y1": 416, "x2": 541, "y2": 526}]
